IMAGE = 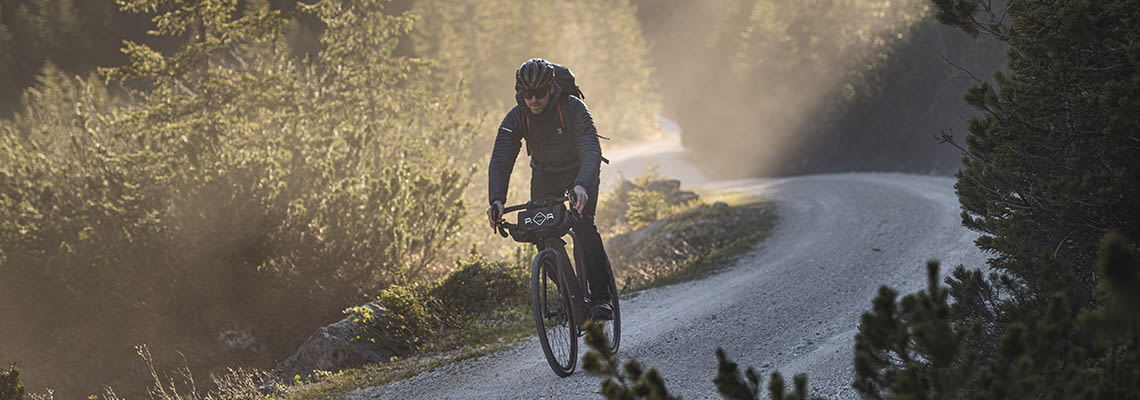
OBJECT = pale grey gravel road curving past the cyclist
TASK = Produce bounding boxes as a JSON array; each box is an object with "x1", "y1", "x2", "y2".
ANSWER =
[{"x1": 348, "y1": 173, "x2": 985, "y2": 400}]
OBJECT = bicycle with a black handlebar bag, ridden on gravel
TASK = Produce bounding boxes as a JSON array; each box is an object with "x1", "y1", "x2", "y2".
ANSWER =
[{"x1": 497, "y1": 196, "x2": 621, "y2": 377}]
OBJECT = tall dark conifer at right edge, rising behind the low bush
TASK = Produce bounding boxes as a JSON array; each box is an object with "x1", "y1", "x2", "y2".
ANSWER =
[{"x1": 936, "y1": 0, "x2": 1140, "y2": 338}]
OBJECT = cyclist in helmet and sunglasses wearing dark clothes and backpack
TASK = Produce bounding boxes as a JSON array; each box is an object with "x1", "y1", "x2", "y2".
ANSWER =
[{"x1": 487, "y1": 58, "x2": 613, "y2": 319}]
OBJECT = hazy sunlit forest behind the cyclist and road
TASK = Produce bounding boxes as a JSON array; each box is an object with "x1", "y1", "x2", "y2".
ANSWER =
[{"x1": 0, "y1": 0, "x2": 1005, "y2": 398}]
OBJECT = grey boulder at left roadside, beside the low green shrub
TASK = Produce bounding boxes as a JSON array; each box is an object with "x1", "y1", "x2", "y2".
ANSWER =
[{"x1": 272, "y1": 303, "x2": 396, "y2": 382}]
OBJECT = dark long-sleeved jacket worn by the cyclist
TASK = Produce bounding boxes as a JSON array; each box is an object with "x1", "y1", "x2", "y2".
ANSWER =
[{"x1": 487, "y1": 82, "x2": 602, "y2": 204}]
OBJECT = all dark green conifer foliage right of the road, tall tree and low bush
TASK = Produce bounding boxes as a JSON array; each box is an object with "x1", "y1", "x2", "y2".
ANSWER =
[{"x1": 855, "y1": 0, "x2": 1140, "y2": 399}]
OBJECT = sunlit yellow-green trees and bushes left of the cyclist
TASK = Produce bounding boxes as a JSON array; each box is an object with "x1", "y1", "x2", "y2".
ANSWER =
[{"x1": 0, "y1": 0, "x2": 472, "y2": 398}]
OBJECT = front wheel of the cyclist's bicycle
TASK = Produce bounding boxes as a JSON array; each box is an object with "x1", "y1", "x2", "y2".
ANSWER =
[{"x1": 530, "y1": 250, "x2": 578, "y2": 377}]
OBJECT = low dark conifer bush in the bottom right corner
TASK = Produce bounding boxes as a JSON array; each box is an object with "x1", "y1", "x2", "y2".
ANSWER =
[{"x1": 854, "y1": 234, "x2": 1140, "y2": 399}]
